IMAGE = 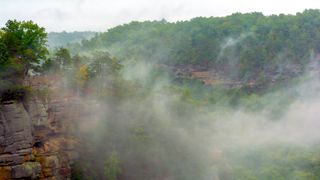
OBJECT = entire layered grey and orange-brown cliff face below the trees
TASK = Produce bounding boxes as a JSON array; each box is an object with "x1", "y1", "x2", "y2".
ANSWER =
[{"x1": 0, "y1": 76, "x2": 81, "y2": 180}]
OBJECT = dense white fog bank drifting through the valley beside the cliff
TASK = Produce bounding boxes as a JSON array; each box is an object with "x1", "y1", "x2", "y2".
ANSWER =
[{"x1": 65, "y1": 49, "x2": 320, "y2": 180}]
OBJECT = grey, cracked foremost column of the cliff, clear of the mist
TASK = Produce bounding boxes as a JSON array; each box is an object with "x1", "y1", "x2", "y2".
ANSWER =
[{"x1": 0, "y1": 102, "x2": 41, "y2": 179}]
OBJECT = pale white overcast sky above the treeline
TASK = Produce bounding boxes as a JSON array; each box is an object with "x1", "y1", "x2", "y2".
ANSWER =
[{"x1": 0, "y1": 0, "x2": 320, "y2": 31}]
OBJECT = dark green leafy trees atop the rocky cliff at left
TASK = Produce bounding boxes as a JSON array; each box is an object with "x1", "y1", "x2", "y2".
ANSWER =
[{"x1": 0, "y1": 20, "x2": 48, "y2": 100}]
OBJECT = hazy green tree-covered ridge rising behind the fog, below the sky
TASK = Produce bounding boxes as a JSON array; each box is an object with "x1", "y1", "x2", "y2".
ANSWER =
[{"x1": 71, "y1": 10, "x2": 320, "y2": 80}]
